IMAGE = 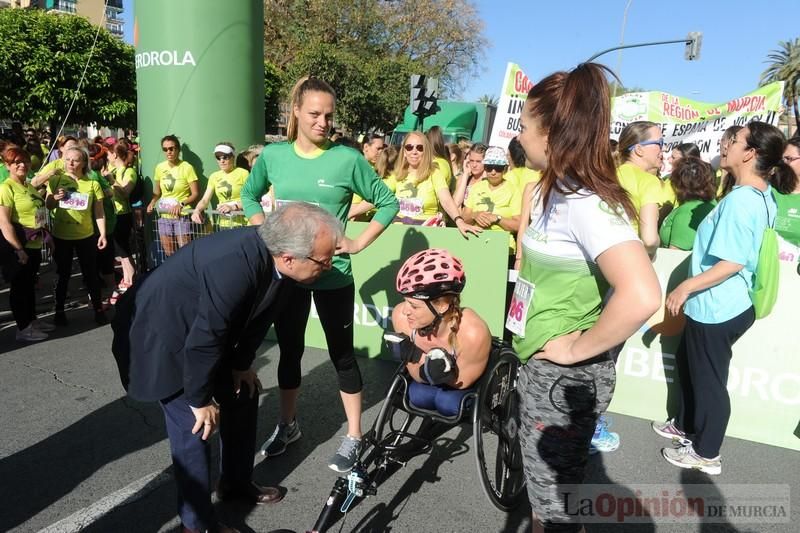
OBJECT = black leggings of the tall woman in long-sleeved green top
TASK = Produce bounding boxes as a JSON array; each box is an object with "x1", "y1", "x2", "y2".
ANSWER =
[{"x1": 275, "y1": 285, "x2": 363, "y2": 394}]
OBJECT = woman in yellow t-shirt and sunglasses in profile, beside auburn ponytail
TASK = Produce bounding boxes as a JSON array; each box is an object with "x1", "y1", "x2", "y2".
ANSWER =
[{"x1": 617, "y1": 120, "x2": 664, "y2": 257}]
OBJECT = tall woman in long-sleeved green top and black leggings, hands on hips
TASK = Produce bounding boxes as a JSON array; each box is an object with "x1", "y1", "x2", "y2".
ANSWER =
[{"x1": 242, "y1": 78, "x2": 397, "y2": 472}]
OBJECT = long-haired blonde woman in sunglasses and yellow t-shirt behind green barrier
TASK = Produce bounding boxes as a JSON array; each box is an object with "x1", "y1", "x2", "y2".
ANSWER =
[{"x1": 394, "y1": 131, "x2": 483, "y2": 237}]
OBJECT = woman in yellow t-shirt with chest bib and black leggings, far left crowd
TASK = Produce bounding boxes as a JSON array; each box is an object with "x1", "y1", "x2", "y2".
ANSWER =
[{"x1": 45, "y1": 148, "x2": 108, "y2": 326}]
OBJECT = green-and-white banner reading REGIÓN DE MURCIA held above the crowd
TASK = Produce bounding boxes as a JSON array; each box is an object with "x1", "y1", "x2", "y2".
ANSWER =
[{"x1": 611, "y1": 82, "x2": 783, "y2": 175}]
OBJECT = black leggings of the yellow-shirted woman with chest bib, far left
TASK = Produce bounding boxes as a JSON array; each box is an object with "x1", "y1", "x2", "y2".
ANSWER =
[{"x1": 53, "y1": 235, "x2": 103, "y2": 311}]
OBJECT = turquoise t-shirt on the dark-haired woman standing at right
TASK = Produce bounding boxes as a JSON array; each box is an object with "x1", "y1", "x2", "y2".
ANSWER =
[{"x1": 684, "y1": 185, "x2": 777, "y2": 324}]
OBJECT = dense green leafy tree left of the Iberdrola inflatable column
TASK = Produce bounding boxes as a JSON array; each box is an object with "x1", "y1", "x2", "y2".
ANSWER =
[{"x1": 0, "y1": 9, "x2": 136, "y2": 128}]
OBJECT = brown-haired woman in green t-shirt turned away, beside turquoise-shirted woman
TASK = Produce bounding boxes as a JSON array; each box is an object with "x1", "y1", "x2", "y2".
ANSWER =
[{"x1": 659, "y1": 157, "x2": 717, "y2": 250}]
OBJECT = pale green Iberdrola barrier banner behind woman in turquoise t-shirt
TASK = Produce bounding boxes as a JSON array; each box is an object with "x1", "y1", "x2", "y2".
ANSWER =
[{"x1": 609, "y1": 249, "x2": 800, "y2": 450}]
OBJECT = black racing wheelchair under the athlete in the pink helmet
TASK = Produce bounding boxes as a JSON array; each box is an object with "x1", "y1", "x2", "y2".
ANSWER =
[{"x1": 312, "y1": 337, "x2": 525, "y2": 532}]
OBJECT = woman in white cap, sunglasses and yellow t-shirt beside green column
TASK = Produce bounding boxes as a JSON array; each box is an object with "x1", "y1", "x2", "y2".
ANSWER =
[{"x1": 192, "y1": 142, "x2": 250, "y2": 228}]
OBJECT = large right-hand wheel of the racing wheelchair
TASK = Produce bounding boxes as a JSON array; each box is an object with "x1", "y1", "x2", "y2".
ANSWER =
[{"x1": 472, "y1": 350, "x2": 525, "y2": 512}]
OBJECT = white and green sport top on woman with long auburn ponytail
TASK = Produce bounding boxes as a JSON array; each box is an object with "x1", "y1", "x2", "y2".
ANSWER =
[{"x1": 507, "y1": 185, "x2": 639, "y2": 362}]
